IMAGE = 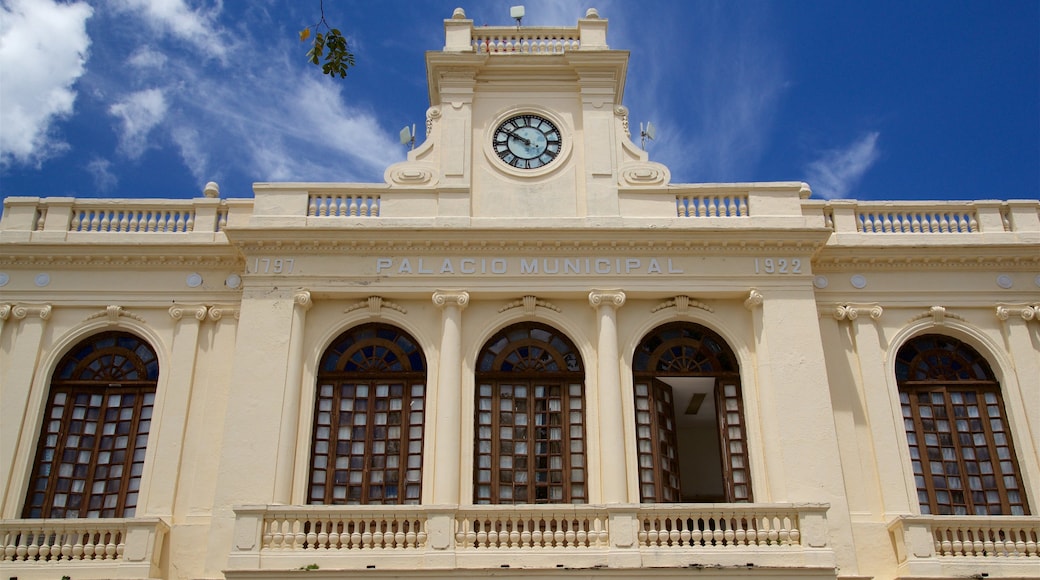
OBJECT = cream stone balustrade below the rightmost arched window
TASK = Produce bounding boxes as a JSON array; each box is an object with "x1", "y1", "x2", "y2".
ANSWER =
[{"x1": 888, "y1": 516, "x2": 1040, "y2": 577}]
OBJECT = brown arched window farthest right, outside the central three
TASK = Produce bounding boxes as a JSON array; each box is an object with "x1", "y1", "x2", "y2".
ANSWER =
[{"x1": 895, "y1": 335, "x2": 1029, "y2": 516}]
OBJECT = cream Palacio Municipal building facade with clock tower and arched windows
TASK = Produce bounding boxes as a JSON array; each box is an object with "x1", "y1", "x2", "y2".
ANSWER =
[{"x1": 0, "y1": 9, "x2": 1040, "y2": 580}]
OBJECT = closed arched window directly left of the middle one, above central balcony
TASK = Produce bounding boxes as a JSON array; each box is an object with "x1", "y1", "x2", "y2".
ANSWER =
[{"x1": 308, "y1": 324, "x2": 426, "y2": 504}]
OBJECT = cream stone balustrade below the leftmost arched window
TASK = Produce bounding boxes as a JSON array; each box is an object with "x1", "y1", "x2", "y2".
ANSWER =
[{"x1": 0, "y1": 518, "x2": 170, "y2": 578}]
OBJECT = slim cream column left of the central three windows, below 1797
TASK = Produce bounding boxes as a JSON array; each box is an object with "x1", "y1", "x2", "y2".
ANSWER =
[{"x1": 275, "y1": 290, "x2": 313, "y2": 505}]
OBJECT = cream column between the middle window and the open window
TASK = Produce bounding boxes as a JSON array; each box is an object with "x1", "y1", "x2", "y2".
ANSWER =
[{"x1": 589, "y1": 290, "x2": 629, "y2": 503}]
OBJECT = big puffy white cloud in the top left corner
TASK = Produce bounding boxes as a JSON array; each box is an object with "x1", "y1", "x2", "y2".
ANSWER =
[{"x1": 0, "y1": 0, "x2": 94, "y2": 165}]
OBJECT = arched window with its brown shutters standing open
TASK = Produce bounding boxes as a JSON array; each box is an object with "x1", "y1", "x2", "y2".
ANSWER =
[{"x1": 632, "y1": 322, "x2": 752, "y2": 503}]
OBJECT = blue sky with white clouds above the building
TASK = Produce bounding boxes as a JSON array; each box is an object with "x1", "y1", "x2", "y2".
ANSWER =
[{"x1": 0, "y1": 0, "x2": 1040, "y2": 204}]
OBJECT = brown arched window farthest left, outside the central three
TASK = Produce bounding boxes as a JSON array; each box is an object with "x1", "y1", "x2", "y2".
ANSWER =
[{"x1": 23, "y1": 332, "x2": 159, "y2": 518}]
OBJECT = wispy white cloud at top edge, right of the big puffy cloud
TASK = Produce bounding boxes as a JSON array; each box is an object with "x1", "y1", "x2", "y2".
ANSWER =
[{"x1": 112, "y1": 0, "x2": 227, "y2": 60}]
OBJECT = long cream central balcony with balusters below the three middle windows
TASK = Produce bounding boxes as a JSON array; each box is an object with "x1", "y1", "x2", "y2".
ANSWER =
[{"x1": 227, "y1": 504, "x2": 836, "y2": 579}]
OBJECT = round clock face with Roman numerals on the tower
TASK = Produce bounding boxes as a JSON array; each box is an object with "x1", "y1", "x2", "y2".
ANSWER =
[{"x1": 491, "y1": 114, "x2": 563, "y2": 169}]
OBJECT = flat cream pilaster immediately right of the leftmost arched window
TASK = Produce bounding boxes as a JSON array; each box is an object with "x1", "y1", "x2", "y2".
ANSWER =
[{"x1": 140, "y1": 305, "x2": 208, "y2": 516}]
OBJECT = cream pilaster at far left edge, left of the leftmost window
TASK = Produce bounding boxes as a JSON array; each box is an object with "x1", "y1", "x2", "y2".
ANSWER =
[{"x1": 0, "y1": 304, "x2": 52, "y2": 518}]
